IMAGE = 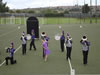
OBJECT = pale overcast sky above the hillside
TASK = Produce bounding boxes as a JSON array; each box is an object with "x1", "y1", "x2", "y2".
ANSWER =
[{"x1": 3, "y1": 0, "x2": 100, "y2": 9}]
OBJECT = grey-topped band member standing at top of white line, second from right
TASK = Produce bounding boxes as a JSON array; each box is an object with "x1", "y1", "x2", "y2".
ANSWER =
[{"x1": 65, "y1": 36, "x2": 72, "y2": 60}]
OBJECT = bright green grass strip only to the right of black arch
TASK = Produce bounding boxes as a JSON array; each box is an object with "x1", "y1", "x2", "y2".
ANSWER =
[{"x1": 38, "y1": 17, "x2": 100, "y2": 24}]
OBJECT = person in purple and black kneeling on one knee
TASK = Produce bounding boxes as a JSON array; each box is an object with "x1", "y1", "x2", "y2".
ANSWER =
[{"x1": 5, "y1": 43, "x2": 16, "y2": 65}]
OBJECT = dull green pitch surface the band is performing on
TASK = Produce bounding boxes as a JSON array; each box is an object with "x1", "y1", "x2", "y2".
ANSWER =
[{"x1": 0, "y1": 24, "x2": 100, "y2": 75}]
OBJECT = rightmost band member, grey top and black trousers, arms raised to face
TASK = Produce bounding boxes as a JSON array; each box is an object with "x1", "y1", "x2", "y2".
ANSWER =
[{"x1": 80, "y1": 36, "x2": 90, "y2": 65}]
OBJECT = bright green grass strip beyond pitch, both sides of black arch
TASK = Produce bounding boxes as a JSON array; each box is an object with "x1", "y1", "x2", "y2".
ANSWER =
[{"x1": 0, "y1": 17, "x2": 100, "y2": 25}]
